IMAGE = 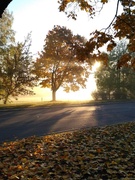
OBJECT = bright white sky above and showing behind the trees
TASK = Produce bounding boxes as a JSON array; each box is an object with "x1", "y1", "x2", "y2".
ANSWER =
[{"x1": 8, "y1": 0, "x2": 121, "y2": 101}]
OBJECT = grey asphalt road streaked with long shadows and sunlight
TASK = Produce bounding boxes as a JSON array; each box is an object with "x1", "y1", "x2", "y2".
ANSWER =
[{"x1": 0, "y1": 102, "x2": 135, "y2": 143}]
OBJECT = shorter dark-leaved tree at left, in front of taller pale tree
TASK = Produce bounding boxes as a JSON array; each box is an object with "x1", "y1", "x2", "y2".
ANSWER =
[{"x1": 0, "y1": 35, "x2": 35, "y2": 104}]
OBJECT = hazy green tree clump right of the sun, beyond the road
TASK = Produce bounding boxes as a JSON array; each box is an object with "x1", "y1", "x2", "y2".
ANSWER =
[{"x1": 93, "y1": 41, "x2": 135, "y2": 99}]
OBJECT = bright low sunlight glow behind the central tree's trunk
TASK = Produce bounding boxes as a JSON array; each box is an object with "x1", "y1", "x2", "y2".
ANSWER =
[{"x1": 12, "y1": 62, "x2": 100, "y2": 102}]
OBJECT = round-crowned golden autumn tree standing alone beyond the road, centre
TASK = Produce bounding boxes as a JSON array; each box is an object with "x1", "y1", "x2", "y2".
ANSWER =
[{"x1": 35, "y1": 26, "x2": 89, "y2": 101}]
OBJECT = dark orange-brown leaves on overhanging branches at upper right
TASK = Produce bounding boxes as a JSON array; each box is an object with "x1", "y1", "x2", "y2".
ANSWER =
[{"x1": 59, "y1": 0, "x2": 135, "y2": 69}]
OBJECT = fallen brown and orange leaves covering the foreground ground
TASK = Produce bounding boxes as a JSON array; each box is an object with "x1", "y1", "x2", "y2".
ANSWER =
[{"x1": 0, "y1": 122, "x2": 135, "y2": 180}]
